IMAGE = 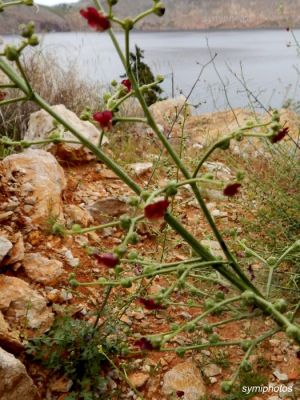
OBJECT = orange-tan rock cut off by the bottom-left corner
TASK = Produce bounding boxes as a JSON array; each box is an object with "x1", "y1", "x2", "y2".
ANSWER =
[{"x1": 0, "y1": 348, "x2": 40, "y2": 400}]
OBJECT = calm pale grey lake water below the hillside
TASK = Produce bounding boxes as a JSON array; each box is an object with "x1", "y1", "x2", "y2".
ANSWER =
[{"x1": 5, "y1": 30, "x2": 300, "y2": 112}]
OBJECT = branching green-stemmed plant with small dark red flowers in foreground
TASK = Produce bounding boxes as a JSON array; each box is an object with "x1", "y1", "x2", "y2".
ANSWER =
[{"x1": 0, "y1": 0, "x2": 300, "y2": 397}]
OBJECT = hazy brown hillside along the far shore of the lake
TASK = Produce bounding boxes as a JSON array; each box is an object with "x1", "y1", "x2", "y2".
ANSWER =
[{"x1": 0, "y1": 0, "x2": 300, "y2": 34}]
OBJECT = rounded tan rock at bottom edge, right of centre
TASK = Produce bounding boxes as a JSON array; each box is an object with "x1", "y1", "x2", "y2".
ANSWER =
[{"x1": 162, "y1": 360, "x2": 206, "y2": 400}]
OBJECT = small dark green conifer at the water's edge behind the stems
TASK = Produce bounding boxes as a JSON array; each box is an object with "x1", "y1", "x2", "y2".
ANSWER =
[{"x1": 130, "y1": 46, "x2": 163, "y2": 106}]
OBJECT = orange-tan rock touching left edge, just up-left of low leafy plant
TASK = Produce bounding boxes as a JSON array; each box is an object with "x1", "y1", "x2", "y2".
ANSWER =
[{"x1": 0, "y1": 275, "x2": 53, "y2": 330}]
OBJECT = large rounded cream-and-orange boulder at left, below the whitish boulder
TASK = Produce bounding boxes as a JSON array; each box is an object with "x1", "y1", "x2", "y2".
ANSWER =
[{"x1": 3, "y1": 149, "x2": 66, "y2": 226}]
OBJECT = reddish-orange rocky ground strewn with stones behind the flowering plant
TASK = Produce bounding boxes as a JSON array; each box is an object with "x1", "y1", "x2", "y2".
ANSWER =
[{"x1": 0, "y1": 97, "x2": 300, "y2": 400}]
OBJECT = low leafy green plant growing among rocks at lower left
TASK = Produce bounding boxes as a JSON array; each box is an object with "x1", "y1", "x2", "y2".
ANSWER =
[{"x1": 27, "y1": 317, "x2": 127, "y2": 400}]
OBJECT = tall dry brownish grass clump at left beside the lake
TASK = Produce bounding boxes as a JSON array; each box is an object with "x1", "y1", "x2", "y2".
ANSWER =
[{"x1": 0, "y1": 50, "x2": 101, "y2": 139}]
